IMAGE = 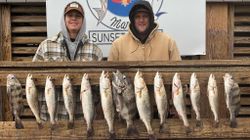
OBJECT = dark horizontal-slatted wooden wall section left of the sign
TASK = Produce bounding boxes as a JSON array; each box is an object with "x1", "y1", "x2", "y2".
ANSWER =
[{"x1": 11, "y1": 3, "x2": 47, "y2": 61}]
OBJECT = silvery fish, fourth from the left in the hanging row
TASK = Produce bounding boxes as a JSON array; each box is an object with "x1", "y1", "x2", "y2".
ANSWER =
[{"x1": 62, "y1": 74, "x2": 75, "y2": 129}]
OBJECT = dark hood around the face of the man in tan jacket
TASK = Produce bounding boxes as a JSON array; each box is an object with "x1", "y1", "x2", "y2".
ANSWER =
[{"x1": 129, "y1": 0, "x2": 156, "y2": 44}]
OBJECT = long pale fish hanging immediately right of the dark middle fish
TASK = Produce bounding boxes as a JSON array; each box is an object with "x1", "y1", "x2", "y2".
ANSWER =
[{"x1": 134, "y1": 70, "x2": 155, "y2": 139}]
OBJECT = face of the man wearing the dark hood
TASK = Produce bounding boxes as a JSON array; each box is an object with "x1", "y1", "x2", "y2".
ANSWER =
[{"x1": 134, "y1": 12, "x2": 149, "y2": 33}]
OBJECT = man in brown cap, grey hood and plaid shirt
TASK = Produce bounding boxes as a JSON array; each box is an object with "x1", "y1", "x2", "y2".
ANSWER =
[{"x1": 32, "y1": 2, "x2": 103, "y2": 121}]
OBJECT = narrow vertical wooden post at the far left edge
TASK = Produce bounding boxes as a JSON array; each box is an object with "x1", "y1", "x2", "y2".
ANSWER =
[{"x1": 1, "y1": 5, "x2": 12, "y2": 61}]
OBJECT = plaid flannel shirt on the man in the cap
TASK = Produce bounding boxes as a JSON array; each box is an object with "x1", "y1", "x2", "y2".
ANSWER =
[{"x1": 32, "y1": 33, "x2": 103, "y2": 121}]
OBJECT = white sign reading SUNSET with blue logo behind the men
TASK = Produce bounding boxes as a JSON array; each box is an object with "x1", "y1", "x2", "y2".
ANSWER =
[{"x1": 47, "y1": 0, "x2": 206, "y2": 56}]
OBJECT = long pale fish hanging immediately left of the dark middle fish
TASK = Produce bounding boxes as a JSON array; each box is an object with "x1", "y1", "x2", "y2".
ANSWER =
[{"x1": 100, "y1": 71, "x2": 116, "y2": 139}]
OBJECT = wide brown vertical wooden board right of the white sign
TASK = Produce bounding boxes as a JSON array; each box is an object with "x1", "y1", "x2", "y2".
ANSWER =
[{"x1": 206, "y1": 3, "x2": 232, "y2": 60}]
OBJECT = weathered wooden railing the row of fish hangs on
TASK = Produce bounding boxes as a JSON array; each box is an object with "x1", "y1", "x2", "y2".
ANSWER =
[{"x1": 0, "y1": 60, "x2": 250, "y2": 139}]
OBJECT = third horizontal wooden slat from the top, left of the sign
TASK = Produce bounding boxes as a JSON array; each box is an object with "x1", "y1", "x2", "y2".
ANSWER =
[{"x1": 12, "y1": 26, "x2": 47, "y2": 33}]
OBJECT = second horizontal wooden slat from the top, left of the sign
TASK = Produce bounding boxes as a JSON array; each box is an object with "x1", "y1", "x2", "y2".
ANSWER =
[{"x1": 11, "y1": 16, "x2": 46, "y2": 23}]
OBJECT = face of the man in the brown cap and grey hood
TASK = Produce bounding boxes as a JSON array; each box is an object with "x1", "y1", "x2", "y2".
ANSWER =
[{"x1": 65, "y1": 10, "x2": 83, "y2": 33}]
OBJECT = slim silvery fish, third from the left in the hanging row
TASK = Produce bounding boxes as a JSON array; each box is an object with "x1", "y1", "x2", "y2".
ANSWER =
[{"x1": 45, "y1": 76, "x2": 56, "y2": 130}]
